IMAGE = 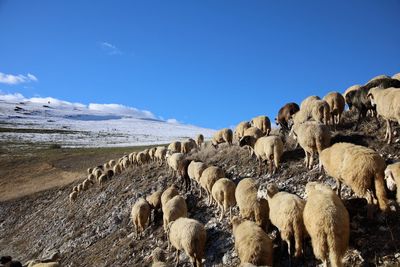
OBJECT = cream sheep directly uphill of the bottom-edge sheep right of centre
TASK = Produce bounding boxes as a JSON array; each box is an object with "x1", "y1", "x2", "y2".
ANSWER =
[{"x1": 235, "y1": 178, "x2": 269, "y2": 229}]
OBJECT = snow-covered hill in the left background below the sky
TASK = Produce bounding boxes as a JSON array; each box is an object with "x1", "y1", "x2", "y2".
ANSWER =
[{"x1": 0, "y1": 94, "x2": 214, "y2": 147}]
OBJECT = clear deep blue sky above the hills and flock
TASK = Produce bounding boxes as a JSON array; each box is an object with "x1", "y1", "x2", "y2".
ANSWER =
[{"x1": 0, "y1": 0, "x2": 400, "y2": 129}]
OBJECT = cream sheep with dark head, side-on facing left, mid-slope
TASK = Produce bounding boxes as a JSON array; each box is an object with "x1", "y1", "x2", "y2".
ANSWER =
[{"x1": 239, "y1": 135, "x2": 283, "y2": 175}]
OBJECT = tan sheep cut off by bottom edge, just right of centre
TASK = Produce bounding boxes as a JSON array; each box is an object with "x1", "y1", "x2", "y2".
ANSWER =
[{"x1": 231, "y1": 216, "x2": 273, "y2": 266}]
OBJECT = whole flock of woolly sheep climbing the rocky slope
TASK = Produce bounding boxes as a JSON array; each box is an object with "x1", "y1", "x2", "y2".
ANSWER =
[{"x1": 64, "y1": 74, "x2": 400, "y2": 266}]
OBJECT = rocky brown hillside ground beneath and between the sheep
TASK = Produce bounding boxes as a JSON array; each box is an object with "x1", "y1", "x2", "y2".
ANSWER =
[{"x1": 0, "y1": 111, "x2": 400, "y2": 266}]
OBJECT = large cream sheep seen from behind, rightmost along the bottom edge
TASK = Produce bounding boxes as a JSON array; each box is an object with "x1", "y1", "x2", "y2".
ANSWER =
[{"x1": 303, "y1": 182, "x2": 350, "y2": 267}]
